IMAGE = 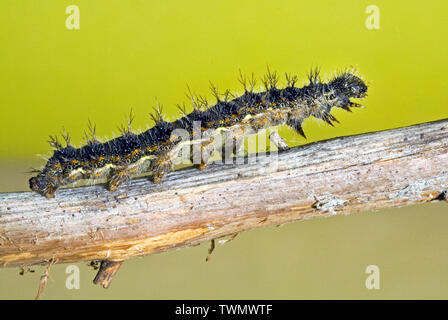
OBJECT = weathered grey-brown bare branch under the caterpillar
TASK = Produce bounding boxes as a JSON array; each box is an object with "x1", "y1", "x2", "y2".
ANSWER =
[{"x1": 0, "y1": 120, "x2": 448, "y2": 267}]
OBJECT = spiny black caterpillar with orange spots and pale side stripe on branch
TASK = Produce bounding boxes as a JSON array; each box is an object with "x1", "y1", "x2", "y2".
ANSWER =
[{"x1": 29, "y1": 68, "x2": 367, "y2": 198}]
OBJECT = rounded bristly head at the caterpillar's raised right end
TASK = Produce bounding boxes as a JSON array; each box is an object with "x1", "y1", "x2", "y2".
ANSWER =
[{"x1": 329, "y1": 72, "x2": 367, "y2": 101}]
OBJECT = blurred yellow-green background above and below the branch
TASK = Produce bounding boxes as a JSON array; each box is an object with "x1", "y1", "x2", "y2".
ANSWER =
[{"x1": 0, "y1": 0, "x2": 448, "y2": 299}]
